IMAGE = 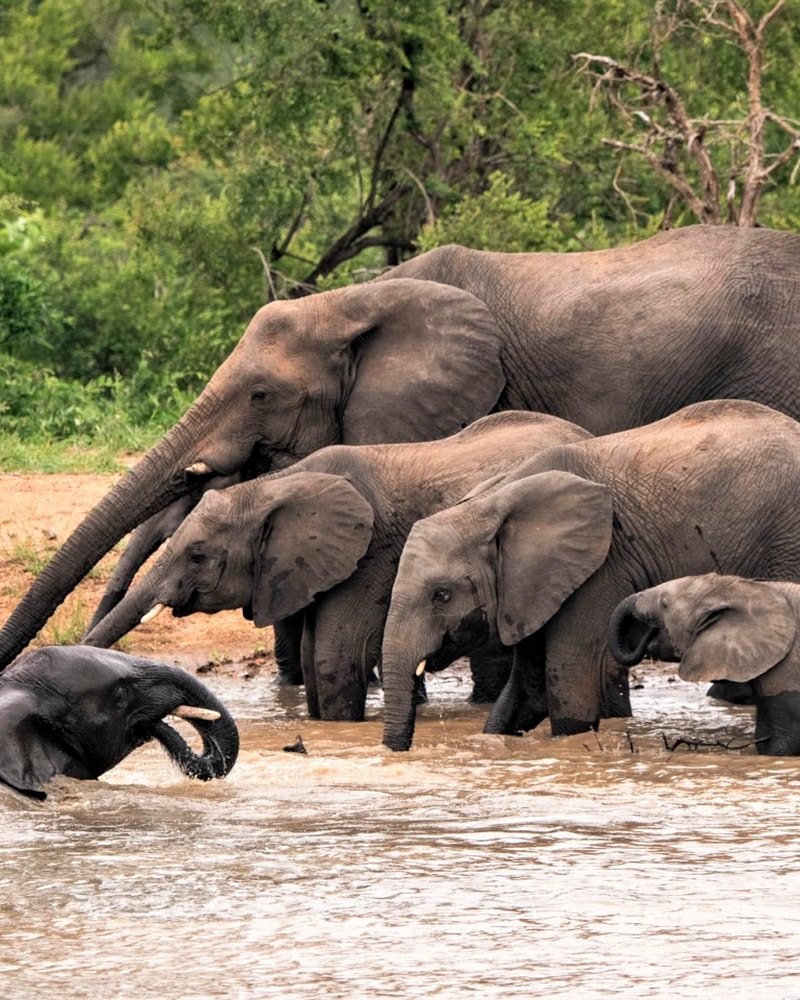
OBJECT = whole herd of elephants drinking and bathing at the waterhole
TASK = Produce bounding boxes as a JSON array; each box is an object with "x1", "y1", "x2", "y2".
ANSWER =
[{"x1": 0, "y1": 226, "x2": 800, "y2": 797}]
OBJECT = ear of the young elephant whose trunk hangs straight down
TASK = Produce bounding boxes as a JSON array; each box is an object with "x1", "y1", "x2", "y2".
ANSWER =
[{"x1": 490, "y1": 472, "x2": 613, "y2": 646}]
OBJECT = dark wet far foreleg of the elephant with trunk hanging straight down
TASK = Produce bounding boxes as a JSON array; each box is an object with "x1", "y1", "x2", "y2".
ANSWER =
[{"x1": 483, "y1": 629, "x2": 548, "y2": 736}]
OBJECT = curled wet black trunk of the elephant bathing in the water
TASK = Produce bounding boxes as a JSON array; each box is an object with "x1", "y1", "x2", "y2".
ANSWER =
[{"x1": 151, "y1": 667, "x2": 239, "y2": 781}]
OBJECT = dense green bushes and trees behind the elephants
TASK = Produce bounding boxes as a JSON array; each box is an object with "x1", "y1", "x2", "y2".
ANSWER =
[{"x1": 0, "y1": 0, "x2": 800, "y2": 461}]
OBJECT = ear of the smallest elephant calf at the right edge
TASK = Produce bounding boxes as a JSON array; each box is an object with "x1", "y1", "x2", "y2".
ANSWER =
[{"x1": 678, "y1": 577, "x2": 797, "y2": 681}]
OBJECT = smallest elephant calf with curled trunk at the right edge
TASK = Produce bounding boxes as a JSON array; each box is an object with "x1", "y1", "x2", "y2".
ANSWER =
[{"x1": 608, "y1": 573, "x2": 800, "y2": 756}]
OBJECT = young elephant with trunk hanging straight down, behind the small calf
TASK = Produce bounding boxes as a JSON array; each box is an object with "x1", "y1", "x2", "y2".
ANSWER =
[{"x1": 382, "y1": 400, "x2": 800, "y2": 750}]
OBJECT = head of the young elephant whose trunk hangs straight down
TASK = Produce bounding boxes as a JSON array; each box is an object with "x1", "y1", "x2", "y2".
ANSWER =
[{"x1": 382, "y1": 472, "x2": 612, "y2": 750}]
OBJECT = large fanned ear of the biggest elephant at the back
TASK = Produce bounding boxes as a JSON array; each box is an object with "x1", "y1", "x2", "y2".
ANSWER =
[{"x1": 342, "y1": 278, "x2": 505, "y2": 442}]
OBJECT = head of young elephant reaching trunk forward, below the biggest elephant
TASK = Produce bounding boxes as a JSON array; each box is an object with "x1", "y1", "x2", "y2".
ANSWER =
[{"x1": 84, "y1": 471, "x2": 373, "y2": 646}]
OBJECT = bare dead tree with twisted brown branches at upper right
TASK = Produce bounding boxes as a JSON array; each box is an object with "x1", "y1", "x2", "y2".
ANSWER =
[{"x1": 574, "y1": 0, "x2": 800, "y2": 226}]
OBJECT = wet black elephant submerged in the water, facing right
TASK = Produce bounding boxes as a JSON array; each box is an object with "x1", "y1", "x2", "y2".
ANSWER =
[{"x1": 0, "y1": 646, "x2": 239, "y2": 799}]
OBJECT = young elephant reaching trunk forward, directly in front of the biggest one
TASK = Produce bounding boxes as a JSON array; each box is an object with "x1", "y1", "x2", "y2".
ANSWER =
[{"x1": 85, "y1": 411, "x2": 590, "y2": 721}]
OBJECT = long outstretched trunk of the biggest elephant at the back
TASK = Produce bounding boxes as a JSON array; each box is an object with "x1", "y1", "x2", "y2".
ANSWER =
[{"x1": 0, "y1": 414, "x2": 216, "y2": 670}]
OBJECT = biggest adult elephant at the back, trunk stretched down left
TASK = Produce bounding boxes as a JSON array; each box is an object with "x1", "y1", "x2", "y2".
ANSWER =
[{"x1": 0, "y1": 226, "x2": 800, "y2": 666}]
